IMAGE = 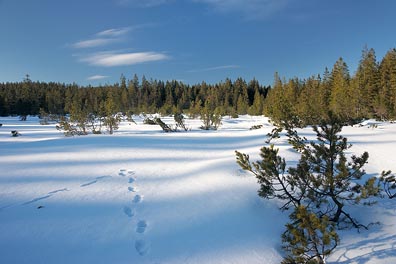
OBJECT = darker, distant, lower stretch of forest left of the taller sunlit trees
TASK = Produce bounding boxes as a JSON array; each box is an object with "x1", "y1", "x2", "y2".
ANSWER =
[{"x1": 0, "y1": 75, "x2": 270, "y2": 116}]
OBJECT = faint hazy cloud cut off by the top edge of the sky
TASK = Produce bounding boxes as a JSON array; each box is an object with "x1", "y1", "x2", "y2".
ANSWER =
[{"x1": 192, "y1": 0, "x2": 292, "y2": 19}]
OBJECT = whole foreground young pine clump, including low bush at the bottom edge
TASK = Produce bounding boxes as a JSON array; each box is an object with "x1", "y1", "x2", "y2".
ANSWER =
[{"x1": 236, "y1": 113, "x2": 380, "y2": 264}]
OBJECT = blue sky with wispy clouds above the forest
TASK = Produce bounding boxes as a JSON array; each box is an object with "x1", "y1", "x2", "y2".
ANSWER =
[{"x1": 0, "y1": 0, "x2": 396, "y2": 85}]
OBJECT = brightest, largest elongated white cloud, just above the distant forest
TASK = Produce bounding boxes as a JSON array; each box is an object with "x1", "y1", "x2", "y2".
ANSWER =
[{"x1": 81, "y1": 51, "x2": 169, "y2": 67}]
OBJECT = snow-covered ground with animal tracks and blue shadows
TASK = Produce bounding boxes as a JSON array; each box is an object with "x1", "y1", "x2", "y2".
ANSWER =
[{"x1": 0, "y1": 116, "x2": 396, "y2": 264}]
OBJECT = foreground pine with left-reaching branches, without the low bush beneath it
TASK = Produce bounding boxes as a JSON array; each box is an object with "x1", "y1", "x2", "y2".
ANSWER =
[{"x1": 236, "y1": 113, "x2": 380, "y2": 228}]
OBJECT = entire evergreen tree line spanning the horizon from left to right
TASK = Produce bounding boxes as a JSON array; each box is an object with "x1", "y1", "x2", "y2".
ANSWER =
[{"x1": 0, "y1": 47, "x2": 396, "y2": 126}]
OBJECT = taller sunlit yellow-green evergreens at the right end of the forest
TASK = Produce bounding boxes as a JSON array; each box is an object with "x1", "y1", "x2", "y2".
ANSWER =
[{"x1": 264, "y1": 47, "x2": 396, "y2": 126}]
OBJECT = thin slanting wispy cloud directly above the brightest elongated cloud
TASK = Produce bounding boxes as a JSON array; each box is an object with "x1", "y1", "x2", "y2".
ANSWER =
[{"x1": 72, "y1": 27, "x2": 132, "y2": 49}]
